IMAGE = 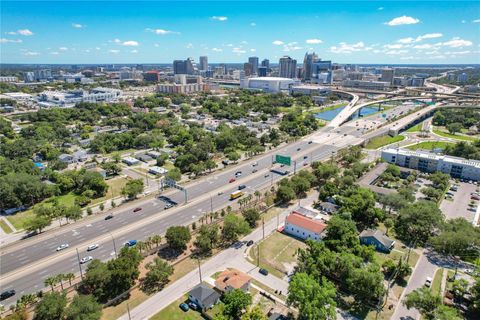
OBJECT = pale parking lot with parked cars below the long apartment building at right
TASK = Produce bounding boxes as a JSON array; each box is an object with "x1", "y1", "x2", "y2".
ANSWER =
[{"x1": 440, "y1": 182, "x2": 479, "y2": 222}]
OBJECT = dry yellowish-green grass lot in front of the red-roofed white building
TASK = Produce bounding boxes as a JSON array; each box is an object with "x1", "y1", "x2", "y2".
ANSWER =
[{"x1": 249, "y1": 232, "x2": 306, "y2": 278}]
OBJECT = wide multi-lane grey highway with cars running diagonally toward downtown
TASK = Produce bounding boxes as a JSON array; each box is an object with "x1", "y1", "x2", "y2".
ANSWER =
[{"x1": 0, "y1": 102, "x2": 418, "y2": 306}]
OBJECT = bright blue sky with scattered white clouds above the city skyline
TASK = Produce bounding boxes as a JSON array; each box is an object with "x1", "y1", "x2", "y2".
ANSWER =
[{"x1": 0, "y1": 0, "x2": 480, "y2": 64}]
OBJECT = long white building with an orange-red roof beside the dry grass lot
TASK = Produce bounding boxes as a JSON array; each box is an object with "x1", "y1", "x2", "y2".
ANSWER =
[{"x1": 283, "y1": 211, "x2": 327, "y2": 240}]
